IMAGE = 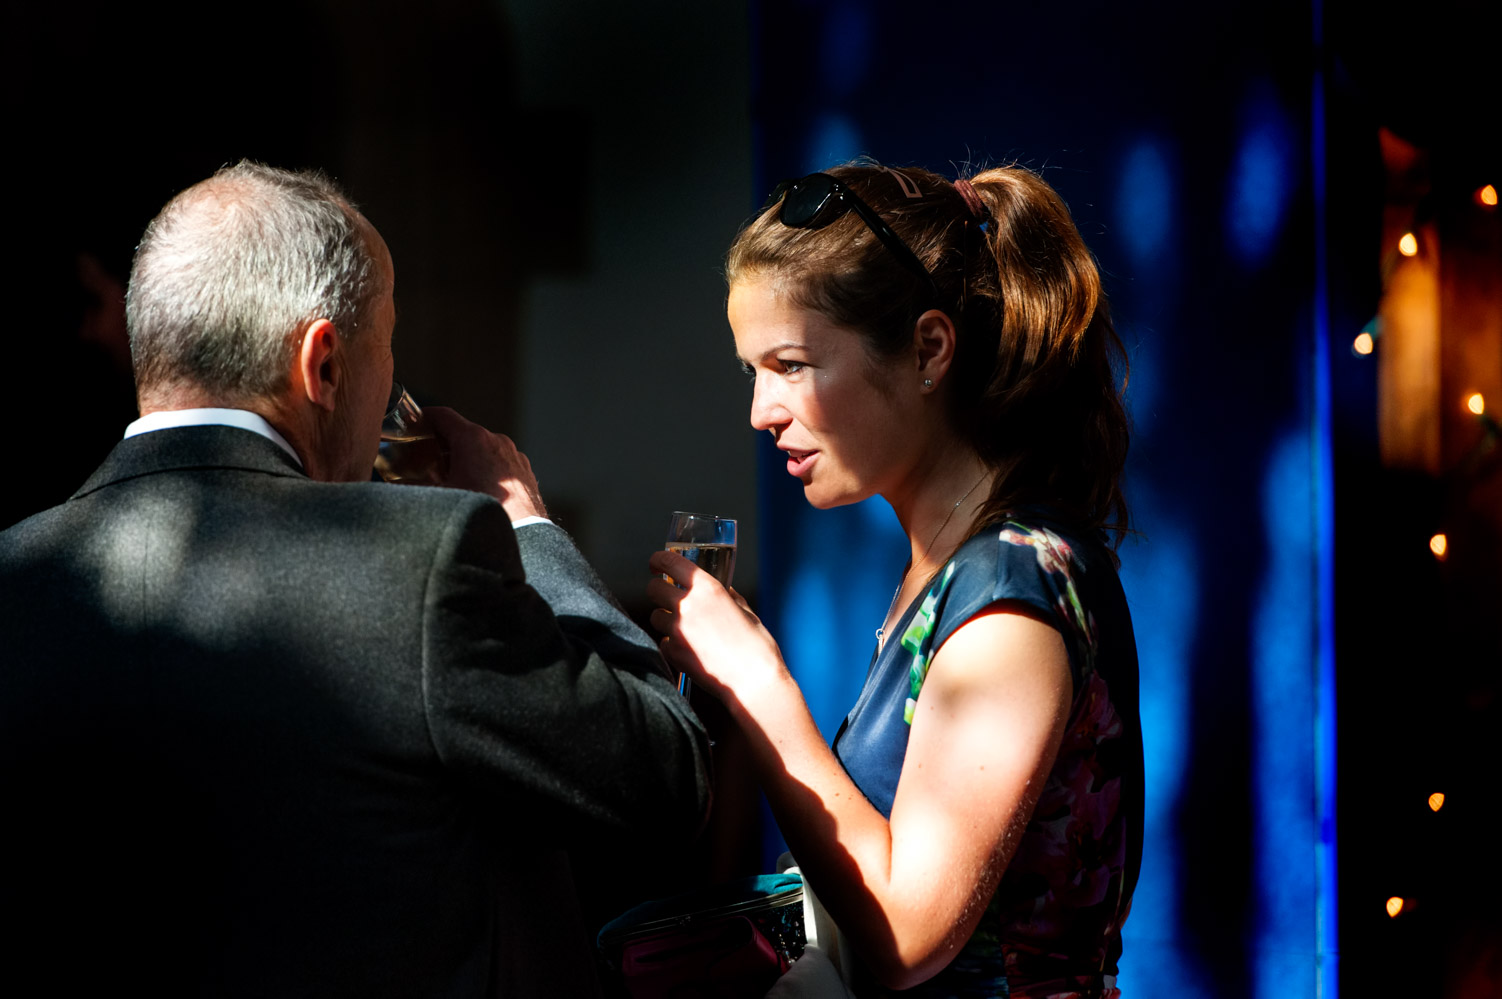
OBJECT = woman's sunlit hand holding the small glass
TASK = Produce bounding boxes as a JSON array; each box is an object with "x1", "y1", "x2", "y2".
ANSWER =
[{"x1": 647, "y1": 551, "x2": 789, "y2": 706}]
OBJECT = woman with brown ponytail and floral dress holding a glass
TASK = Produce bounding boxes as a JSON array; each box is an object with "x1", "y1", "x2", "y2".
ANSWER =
[{"x1": 649, "y1": 164, "x2": 1143, "y2": 999}]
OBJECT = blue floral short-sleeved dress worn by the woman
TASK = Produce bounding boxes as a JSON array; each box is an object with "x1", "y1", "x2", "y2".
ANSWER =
[{"x1": 834, "y1": 514, "x2": 1143, "y2": 999}]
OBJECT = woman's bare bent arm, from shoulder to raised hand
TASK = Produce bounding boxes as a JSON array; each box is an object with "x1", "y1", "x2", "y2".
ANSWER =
[{"x1": 652, "y1": 553, "x2": 1072, "y2": 988}]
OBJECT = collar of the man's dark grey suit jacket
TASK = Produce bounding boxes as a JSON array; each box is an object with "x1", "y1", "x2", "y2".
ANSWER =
[{"x1": 74, "y1": 427, "x2": 308, "y2": 499}]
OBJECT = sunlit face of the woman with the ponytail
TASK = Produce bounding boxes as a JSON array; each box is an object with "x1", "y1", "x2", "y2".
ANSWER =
[{"x1": 727, "y1": 279, "x2": 922, "y2": 509}]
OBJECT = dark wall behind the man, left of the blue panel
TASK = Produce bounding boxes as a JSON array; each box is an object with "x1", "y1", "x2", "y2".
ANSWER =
[{"x1": 0, "y1": 0, "x2": 757, "y2": 605}]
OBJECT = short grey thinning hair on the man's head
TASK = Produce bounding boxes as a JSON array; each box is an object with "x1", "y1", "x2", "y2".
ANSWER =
[{"x1": 125, "y1": 161, "x2": 383, "y2": 404}]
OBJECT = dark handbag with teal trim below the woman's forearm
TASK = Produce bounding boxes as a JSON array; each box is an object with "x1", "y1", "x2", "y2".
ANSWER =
[{"x1": 595, "y1": 873, "x2": 804, "y2": 999}]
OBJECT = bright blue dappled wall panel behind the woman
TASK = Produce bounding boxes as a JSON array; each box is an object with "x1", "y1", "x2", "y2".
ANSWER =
[{"x1": 753, "y1": 0, "x2": 1335, "y2": 999}]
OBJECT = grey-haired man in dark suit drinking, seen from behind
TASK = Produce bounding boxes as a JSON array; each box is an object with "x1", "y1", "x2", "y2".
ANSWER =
[{"x1": 0, "y1": 162, "x2": 709, "y2": 999}]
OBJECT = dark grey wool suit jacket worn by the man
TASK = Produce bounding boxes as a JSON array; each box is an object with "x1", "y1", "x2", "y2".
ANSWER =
[{"x1": 0, "y1": 427, "x2": 709, "y2": 997}]
